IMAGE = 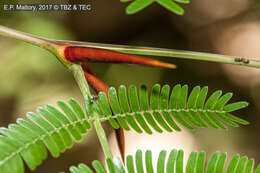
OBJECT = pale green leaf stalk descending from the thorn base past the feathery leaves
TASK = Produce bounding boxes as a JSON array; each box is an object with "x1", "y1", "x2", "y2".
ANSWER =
[{"x1": 70, "y1": 64, "x2": 112, "y2": 158}]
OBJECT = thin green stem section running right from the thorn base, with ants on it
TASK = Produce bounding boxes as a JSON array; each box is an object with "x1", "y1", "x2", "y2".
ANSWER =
[{"x1": 61, "y1": 41, "x2": 260, "y2": 68}]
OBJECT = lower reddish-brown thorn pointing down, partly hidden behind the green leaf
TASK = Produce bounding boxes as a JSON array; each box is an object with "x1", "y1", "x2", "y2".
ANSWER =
[{"x1": 80, "y1": 63, "x2": 125, "y2": 163}]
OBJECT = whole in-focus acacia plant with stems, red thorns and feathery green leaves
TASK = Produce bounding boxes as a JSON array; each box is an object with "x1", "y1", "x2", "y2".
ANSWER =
[{"x1": 0, "y1": 0, "x2": 260, "y2": 173}]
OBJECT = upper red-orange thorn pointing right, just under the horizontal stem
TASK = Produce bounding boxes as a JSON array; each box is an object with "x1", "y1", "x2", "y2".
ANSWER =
[{"x1": 62, "y1": 46, "x2": 176, "y2": 68}]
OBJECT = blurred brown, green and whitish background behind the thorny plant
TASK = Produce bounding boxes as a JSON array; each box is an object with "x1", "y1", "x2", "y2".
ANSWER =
[{"x1": 0, "y1": 0, "x2": 260, "y2": 173}]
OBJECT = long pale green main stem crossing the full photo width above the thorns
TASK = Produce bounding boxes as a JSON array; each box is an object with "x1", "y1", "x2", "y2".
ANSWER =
[{"x1": 0, "y1": 25, "x2": 260, "y2": 68}]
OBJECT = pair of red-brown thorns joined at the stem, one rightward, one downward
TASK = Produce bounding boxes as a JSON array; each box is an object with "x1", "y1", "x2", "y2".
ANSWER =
[{"x1": 59, "y1": 46, "x2": 176, "y2": 160}]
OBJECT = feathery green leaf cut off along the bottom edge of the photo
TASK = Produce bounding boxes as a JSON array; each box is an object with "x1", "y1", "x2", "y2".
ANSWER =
[{"x1": 70, "y1": 149, "x2": 260, "y2": 173}]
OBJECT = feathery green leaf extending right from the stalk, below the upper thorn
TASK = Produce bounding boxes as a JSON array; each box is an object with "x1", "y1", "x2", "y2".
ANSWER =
[{"x1": 98, "y1": 84, "x2": 248, "y2": 134}]
